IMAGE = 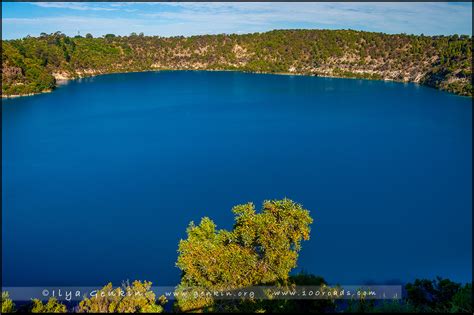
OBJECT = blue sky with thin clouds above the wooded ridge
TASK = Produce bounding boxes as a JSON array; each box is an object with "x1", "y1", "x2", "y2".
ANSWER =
[{"x1": 2, "y1": 2, "x2": 472, "y2": 39}]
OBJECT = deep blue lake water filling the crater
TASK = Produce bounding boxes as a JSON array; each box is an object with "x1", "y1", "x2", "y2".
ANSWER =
[{"x1": 2, "y1": 72, "x2": 472, "y2": 286}]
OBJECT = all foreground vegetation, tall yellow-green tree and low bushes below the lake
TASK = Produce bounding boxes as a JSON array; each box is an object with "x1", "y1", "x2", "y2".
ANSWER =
[{"x1": 2, "y1": 199, "x2": 472, "y2": 314}]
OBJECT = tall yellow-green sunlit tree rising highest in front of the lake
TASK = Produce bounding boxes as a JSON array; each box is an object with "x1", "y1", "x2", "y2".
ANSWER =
[{"x1": 176, "y1": 199, "x2": 313, "y2": 311}]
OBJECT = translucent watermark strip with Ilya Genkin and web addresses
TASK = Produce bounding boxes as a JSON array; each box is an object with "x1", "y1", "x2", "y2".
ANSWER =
[{"x1": 2, "y1": 285, "x2": 402, "y2": 302}]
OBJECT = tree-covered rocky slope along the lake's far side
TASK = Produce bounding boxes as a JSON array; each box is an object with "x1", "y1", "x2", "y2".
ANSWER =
[{"x1": 2, "y1": 30, "x2": 472, "y2": 96}]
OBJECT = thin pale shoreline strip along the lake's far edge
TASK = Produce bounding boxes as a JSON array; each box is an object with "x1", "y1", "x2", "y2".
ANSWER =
[{"x1": 2, "y1": 68, "x2": 472, "y2": 99}]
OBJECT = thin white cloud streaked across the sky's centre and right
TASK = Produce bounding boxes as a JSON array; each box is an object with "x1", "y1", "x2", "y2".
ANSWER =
[{"x1": 137, "y1": 2, "x2": 472, "y2": 34}]
